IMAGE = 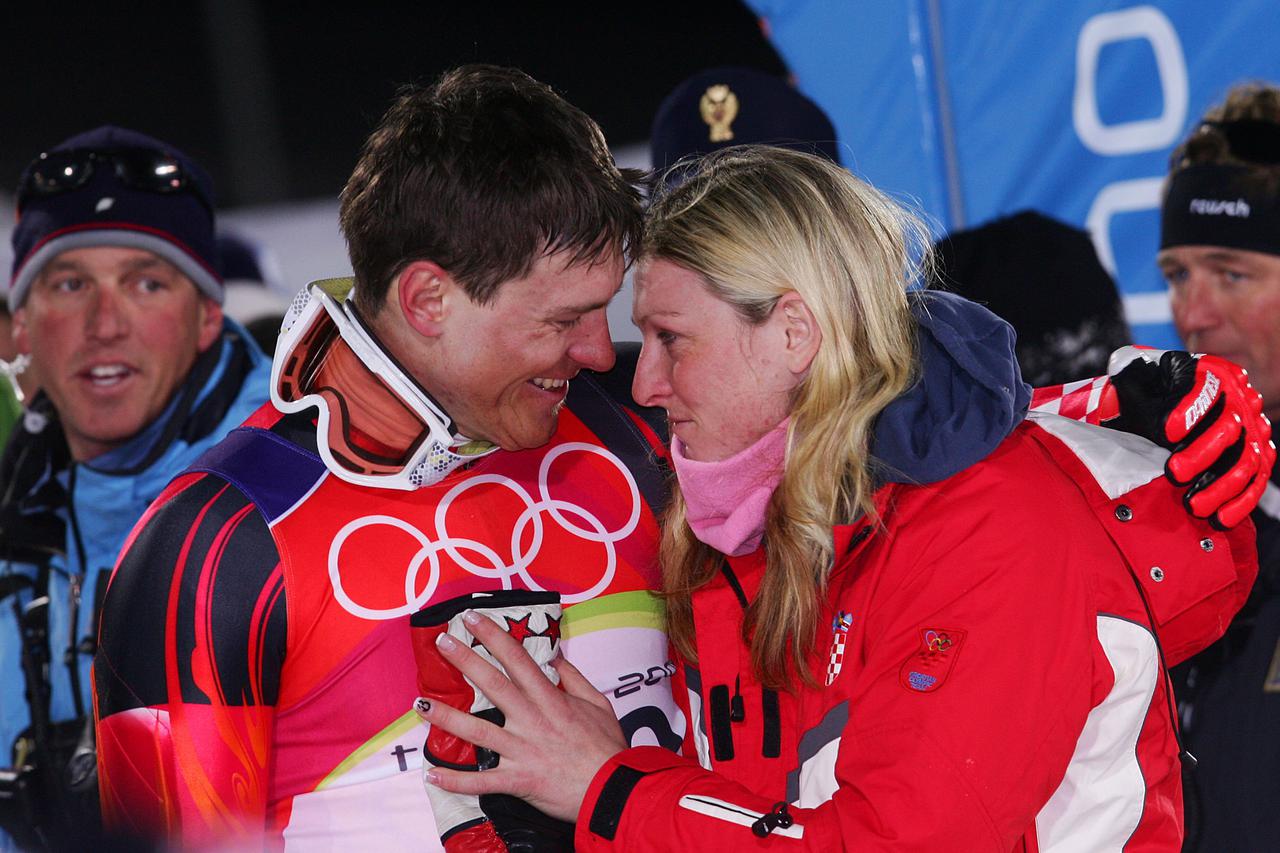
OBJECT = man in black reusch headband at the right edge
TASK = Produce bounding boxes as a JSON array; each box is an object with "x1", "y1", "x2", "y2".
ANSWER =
[{"x1": 1157, "y1": 83, "x2": 1280, "y2": 850}]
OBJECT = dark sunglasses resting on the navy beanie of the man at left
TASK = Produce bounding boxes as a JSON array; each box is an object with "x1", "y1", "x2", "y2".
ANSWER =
[{"x1": 18, "y1": 149, "x2": 214, "y2": 213}]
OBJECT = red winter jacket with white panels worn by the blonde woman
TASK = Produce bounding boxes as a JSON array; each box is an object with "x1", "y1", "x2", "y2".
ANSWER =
[{"x1": 577, "y1": 415, "x2": 1257, "y2": 853}]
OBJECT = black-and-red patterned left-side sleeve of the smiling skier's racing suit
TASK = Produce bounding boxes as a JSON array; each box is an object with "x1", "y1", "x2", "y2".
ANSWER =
[{"x1": 93, "y1": 475, "x2": 285, "y2": 847}]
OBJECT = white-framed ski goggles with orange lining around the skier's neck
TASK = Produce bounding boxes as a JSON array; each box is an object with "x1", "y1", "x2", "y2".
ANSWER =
[{"x1": 271, "y1": 278, "x2": 498, "y2": 491}]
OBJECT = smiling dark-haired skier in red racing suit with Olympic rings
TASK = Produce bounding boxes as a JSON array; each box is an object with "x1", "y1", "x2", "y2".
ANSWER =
[{"x1": 95, "y1": 67, "x2": 684, "y2": 850}]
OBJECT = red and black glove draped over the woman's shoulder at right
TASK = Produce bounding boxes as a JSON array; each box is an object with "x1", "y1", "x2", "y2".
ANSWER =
[{"x1": 1102, "y1": 347, "x2": 1276, "y2": 529}]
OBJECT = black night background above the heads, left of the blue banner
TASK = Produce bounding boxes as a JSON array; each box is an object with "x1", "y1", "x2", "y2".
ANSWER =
[{"x1": 0, "y1": 0, "x2": 785, "y2": 206}]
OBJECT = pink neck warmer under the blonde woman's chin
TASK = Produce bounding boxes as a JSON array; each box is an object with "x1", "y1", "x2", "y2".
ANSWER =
[{"x1": 671, "y1": 419, "x2": 790, "y2": 557}]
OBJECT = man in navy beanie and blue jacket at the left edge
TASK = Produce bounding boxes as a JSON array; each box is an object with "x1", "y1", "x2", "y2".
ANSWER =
[{"x1": 0, "y1": 127, "x2": 270, "y2": 847}]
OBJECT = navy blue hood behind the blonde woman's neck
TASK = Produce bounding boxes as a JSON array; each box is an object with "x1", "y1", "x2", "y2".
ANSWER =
[{"x1": 872, "y1": 291, "x2": 1032, "y2": 483}]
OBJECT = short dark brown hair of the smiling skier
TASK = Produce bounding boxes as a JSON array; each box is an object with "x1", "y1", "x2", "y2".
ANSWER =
[{"x1": 340, "y1": 65, "x2": 641, "y2": 318}]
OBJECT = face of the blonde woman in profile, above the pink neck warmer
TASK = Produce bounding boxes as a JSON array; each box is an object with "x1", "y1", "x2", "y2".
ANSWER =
[{"x1": 631, "y1": 259, "x2": 808, "y2": 462}]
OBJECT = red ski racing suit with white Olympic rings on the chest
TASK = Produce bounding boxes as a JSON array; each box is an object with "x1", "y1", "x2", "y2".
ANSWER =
[{"x1": 95, "y1": 374, "x2": 685, "y2": 850}]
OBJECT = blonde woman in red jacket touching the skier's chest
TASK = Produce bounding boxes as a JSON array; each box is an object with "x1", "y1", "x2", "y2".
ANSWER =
[{"x1": 422, "y1": 149, "x2": 1251, "y2": 853}]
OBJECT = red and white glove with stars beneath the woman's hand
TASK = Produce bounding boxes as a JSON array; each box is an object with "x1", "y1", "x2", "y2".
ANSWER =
[{"x1": 410, "y1": 589, "x2": 573, "y2": 853}]
